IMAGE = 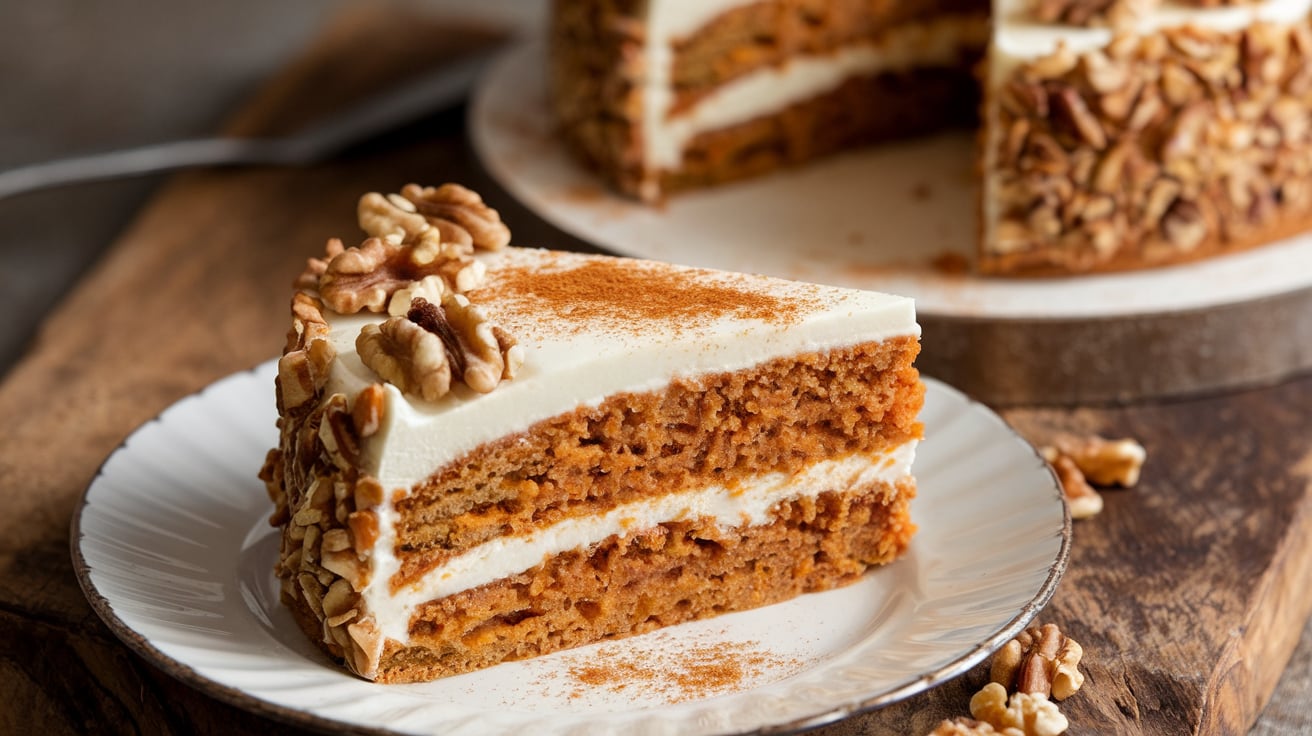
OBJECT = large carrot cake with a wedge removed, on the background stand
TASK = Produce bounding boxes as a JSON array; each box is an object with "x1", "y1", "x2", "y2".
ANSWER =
[{"x1": 550, "y1": 0, "x2": 1312, "y2": 276}]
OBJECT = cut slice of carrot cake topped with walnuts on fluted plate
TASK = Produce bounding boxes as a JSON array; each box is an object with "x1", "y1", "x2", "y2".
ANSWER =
[{"x1": 261, "y1": 185, "x2": 924, "y2": 682}]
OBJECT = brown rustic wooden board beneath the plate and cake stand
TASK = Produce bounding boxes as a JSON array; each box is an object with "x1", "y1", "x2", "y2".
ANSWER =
[{"x1": 0, "y1": 5, "x2": 1312, "y2": 735}]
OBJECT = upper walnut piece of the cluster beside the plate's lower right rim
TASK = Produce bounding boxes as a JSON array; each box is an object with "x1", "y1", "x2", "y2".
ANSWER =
[{"x1": 989, "y1": 623, "x2": 1084, "y2": 701}]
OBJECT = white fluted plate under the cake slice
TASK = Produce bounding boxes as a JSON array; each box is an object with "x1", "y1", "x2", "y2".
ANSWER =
[{"x1": 72, "y1": 362, "x2": 1071, "y2": 736}]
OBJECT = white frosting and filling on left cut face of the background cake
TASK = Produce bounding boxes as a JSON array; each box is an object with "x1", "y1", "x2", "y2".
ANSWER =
[{"x1": 642, "y1": 6, "x2": 988, "y2": 197}]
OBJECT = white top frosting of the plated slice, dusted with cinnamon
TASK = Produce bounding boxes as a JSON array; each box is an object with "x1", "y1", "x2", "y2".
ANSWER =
[{"x1": 325, "y1": 248, "x2": 920, "y2": 496}]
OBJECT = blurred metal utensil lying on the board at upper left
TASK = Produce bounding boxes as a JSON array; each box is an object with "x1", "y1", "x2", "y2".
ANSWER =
[{"x1": 0, "y1": 49, "x2": 497, "y2": 199}]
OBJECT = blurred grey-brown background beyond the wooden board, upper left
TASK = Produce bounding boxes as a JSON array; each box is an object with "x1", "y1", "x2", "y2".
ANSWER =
[{"x1": 0, "y1": 0, "x2": 546, "y2": 377}]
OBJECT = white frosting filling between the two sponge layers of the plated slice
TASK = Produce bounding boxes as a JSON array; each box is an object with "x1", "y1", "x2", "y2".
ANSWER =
[{"x1": 362, "y1": 441, "x2": 917, "y2": 643}]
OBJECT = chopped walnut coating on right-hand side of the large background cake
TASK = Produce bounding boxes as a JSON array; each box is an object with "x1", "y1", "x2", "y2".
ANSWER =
[{"x1": 981, "y1": 21, "x2": 1312, "y2": 272}]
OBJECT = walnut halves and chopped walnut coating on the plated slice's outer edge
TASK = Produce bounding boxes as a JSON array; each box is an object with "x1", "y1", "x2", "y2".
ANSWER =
[{"x1": 260, "y1": 184, "x2": 523, "y2": 678}]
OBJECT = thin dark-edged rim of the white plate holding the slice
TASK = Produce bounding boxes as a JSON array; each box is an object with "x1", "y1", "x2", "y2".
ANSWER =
[{"x1": 70, "y1": 358, "x2": 1073, "y2": 736}]
